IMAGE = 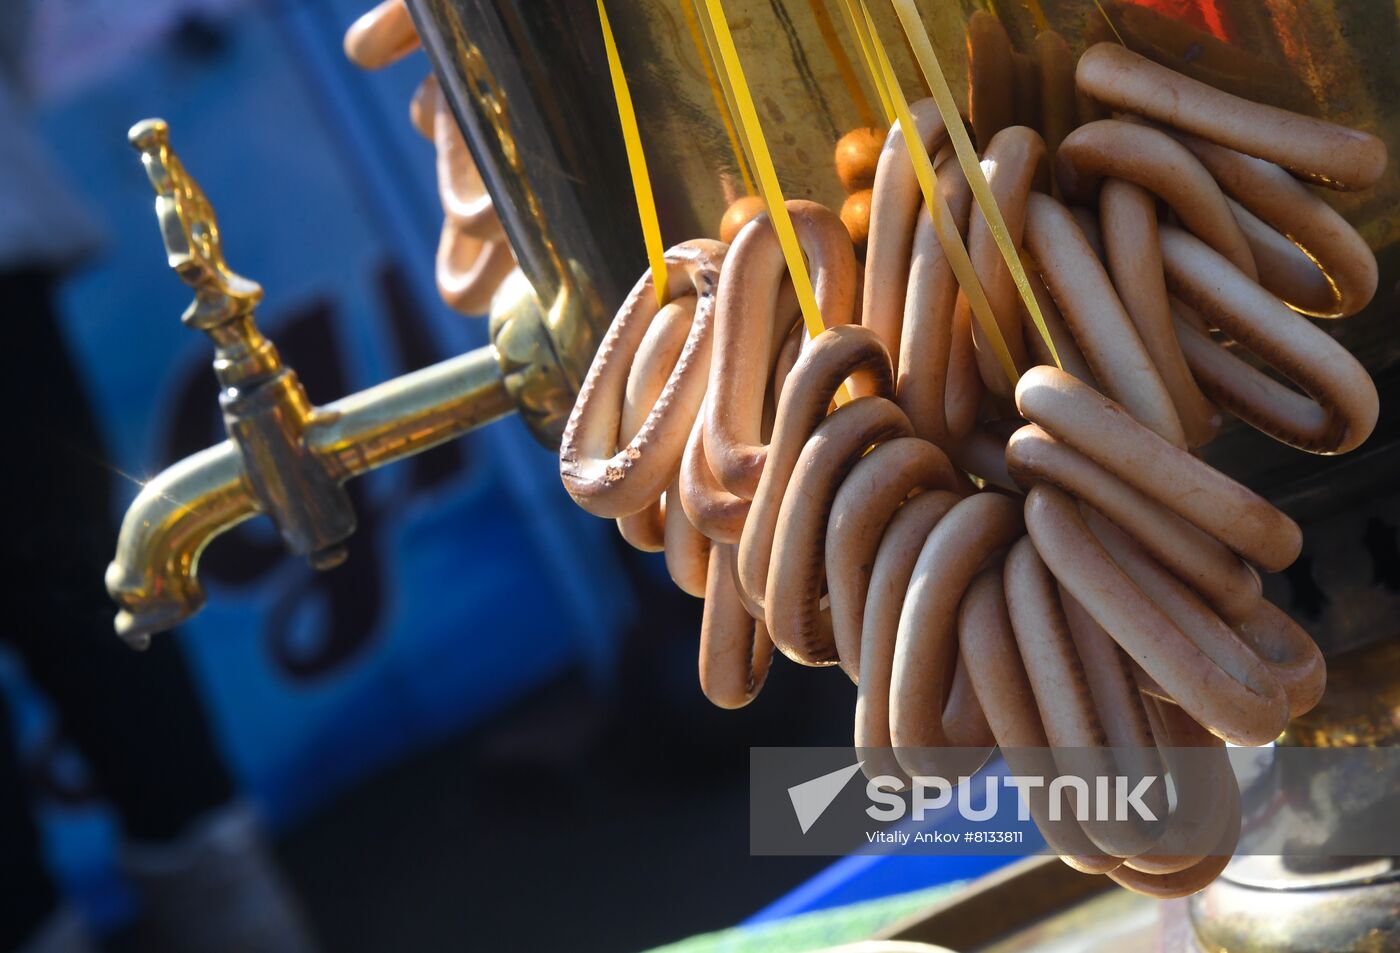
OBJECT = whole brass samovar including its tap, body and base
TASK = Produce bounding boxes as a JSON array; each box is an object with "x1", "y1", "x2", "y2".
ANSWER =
[{"x1": 108, "y1": 0, "x2": 1400, "y2": 949}]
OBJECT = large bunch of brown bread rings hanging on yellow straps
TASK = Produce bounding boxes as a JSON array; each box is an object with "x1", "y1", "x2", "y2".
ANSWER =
[{"x1": 560, "y1": 43, "x2": 1386, "y2": 897}]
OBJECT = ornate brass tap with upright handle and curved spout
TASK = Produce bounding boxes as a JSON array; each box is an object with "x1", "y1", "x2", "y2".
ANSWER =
[{"x1": 106, "y1": 119, "x2": 577, "y2": 648}]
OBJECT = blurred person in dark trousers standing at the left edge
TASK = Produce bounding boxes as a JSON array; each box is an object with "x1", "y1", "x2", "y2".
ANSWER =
[{"x1": 0, "y1": 1, "x2": 314, "y2": 953}]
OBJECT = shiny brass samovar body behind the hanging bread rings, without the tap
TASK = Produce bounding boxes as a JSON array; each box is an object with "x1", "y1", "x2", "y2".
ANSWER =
[{"x1": 410, "y1": 0, "x2": 1400, "y2": 377}]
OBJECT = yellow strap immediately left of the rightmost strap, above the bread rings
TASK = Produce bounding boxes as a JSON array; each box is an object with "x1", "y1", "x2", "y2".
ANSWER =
[{"x1": 858, "y1": 0, "x2": 1019, "y2": 386}]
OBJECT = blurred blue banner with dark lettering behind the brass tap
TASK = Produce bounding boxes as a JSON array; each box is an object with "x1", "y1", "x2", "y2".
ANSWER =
[{"x1": 15, "y1": 0, "x2": 634, "y2": 918}]
